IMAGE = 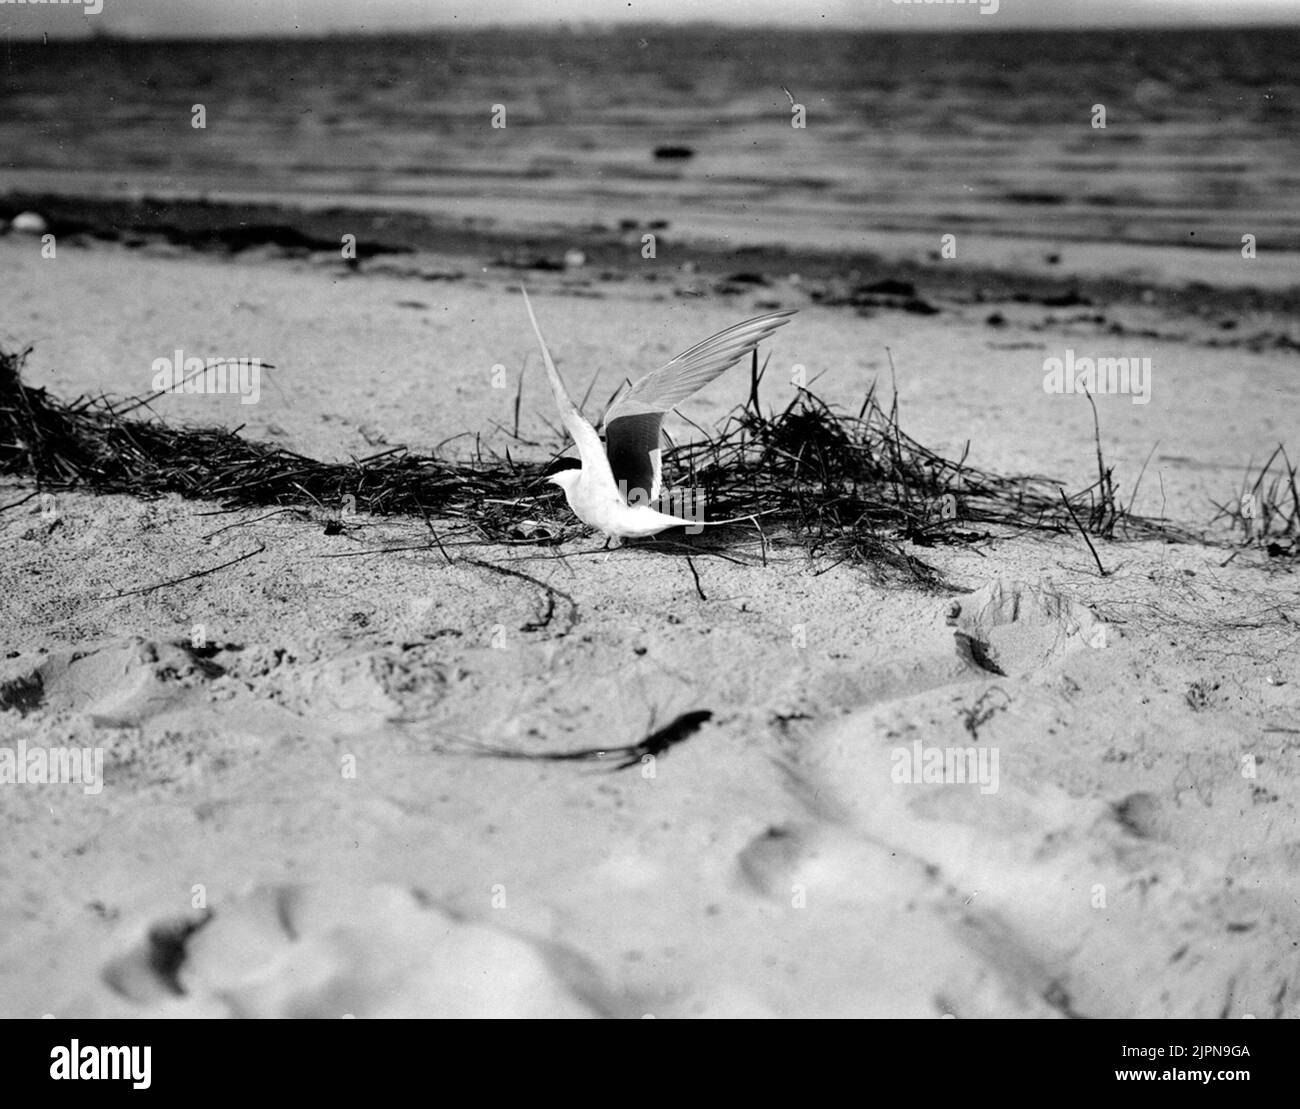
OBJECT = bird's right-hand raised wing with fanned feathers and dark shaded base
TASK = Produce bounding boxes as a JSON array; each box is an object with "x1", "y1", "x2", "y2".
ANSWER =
[{"x1": 605, "y1": 308, "x2": 794, "y2": 504}]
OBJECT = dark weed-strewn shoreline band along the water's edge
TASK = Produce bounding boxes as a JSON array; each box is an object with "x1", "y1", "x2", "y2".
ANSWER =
[{"x1": 10, "y1": 189, "x2": 1300, "y2": 319}]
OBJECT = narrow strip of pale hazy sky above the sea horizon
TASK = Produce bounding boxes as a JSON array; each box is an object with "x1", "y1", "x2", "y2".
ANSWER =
[{"x1": 0, "y1": 0, "x2": 1300, "y2": 38}]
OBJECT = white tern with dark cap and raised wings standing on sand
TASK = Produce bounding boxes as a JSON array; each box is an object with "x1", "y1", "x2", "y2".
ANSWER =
[{"x1": 520, "y1": 289, "x2": 794, "y2": 541}]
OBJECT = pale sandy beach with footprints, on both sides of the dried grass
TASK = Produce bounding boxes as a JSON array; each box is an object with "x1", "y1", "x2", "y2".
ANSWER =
[{"x1": 0, "y1": 211, "x2": 1300, "y2": 1017}]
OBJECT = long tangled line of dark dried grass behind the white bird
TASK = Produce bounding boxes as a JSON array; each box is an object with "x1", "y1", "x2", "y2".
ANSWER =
[{"x1": 0, "y1": 351, "x2": 1196, "y2": 586}]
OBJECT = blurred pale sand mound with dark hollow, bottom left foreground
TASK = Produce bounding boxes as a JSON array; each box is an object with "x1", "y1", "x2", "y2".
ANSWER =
[{"x1": 103, "y1": 885, "x2": 620, "y2": 1018}]
